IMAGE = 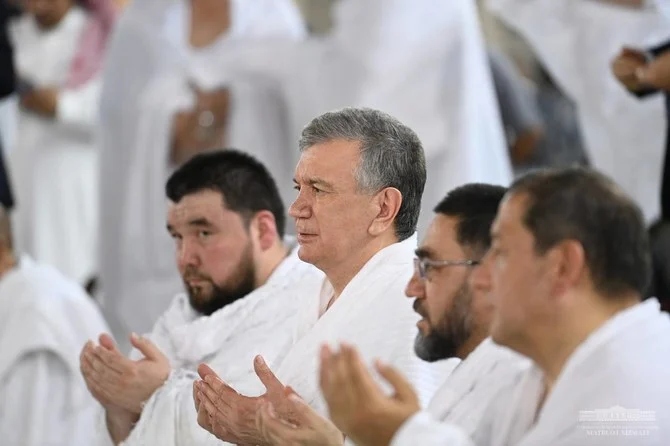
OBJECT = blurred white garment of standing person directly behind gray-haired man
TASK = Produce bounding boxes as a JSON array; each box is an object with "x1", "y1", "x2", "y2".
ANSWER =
[{"x1": 207, "y1": 0, "x2": 511, "y2": 235}]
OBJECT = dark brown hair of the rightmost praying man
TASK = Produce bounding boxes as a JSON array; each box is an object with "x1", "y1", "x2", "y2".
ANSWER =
[{"x1": 510, "y1": 168, "x2": 651, "y2": 298}]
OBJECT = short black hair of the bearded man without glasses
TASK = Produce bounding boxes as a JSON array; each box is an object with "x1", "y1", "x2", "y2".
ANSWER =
[{"x1": 165, "y1": 149, "x2": 286, "y2": 237}]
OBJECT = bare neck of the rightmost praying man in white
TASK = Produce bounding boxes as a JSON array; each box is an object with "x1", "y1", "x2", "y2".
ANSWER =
[{"x1": 527, "y1": 293, "x2": 640, "y2": 391}]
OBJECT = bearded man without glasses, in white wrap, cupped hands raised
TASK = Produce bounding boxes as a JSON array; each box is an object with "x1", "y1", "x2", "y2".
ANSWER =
[{"x1": 81, "y1": 149, "x2": 323, "y2": 446}]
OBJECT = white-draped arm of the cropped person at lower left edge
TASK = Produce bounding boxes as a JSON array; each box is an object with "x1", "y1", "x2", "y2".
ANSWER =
[{"x1": 0, "y1": 351, "x2": 73, "y2": 446}]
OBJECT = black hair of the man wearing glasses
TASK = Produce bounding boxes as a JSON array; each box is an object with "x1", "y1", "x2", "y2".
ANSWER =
[{"x1": 433, "y1": 183, "x2": 507, "y2": 257}]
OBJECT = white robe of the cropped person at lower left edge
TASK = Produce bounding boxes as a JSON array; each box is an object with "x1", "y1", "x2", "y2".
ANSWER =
[{"x1": 0, "y1": 256, "x2": 108, "y2": 446}]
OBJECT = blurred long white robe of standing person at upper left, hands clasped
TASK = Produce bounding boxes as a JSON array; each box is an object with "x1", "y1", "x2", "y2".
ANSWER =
[{"x1": 8, "y1": 7, "x2": 100, "y2": 284}]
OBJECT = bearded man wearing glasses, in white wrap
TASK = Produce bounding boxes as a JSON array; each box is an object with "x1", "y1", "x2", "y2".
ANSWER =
[{"x1": 391, "y1": 184, "x2": 529, "y2": 445}]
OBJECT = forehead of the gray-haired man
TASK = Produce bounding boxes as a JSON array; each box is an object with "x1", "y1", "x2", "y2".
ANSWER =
[{"x1": 295, "y1": 139, "x2": 361, "y2": 181}]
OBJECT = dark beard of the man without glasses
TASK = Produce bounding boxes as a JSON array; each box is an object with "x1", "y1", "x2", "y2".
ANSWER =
[{"x1": 186, "y1": 245, "x2": 256, "y2": 316}]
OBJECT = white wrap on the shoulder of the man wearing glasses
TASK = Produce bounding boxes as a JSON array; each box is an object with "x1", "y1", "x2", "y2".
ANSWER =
[{"x1": 391, "y1": 338, "x2": 530, "y2": 446}]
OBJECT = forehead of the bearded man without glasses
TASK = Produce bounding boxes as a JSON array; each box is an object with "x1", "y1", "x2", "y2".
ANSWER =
[{"x1": 168, "y1": 190, "x2": 237, "y2": 224}]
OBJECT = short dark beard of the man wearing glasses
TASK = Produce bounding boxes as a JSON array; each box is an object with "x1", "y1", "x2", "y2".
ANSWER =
[{"x1": 414, "y1": 284, "x2": 473, "y2": 362}]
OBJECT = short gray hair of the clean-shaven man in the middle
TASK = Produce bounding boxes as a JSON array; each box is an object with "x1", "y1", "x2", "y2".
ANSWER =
[{"x1": 299, "y1": 108, "x2": 426, "y2": 241}]
